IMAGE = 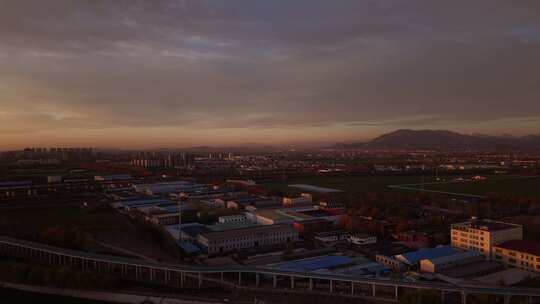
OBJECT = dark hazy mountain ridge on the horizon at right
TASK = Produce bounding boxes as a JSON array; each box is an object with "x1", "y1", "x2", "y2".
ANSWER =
[{"x1": 337, "y1": 130, "x2": 540, "y2": 151}]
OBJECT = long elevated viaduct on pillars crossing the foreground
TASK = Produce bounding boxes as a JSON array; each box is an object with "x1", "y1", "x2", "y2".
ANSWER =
[{"x1": 0, "y1": 237, "x2": 540, "y2": 304}]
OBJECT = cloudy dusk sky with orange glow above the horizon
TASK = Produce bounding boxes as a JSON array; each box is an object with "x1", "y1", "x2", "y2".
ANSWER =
[{"x1": 0, "y1": 0, "x2": 540, "y2": 149}]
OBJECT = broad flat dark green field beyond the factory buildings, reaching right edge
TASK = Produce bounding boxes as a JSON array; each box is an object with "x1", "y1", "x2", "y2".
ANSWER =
[{"x1": 263, "y1": 176, "x2": 540, "y2": 198}]
